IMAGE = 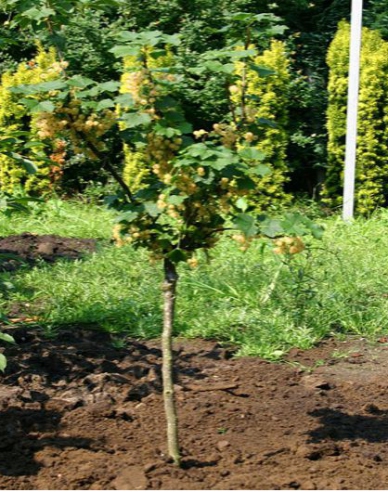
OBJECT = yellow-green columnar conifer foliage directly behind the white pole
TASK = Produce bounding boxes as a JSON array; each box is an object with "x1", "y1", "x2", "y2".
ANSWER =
[{"x1": 323, "y1": 21, "x2": 388, "y2": 215}]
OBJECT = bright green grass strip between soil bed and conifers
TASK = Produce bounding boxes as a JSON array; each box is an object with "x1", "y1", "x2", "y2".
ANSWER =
[{"x1": 0, "y1": 200, "x2": 388, "y2": 359}]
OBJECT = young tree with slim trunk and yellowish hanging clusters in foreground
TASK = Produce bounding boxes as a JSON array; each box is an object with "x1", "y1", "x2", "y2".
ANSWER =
[{"x1": 2, "y1": 3, "x2": 320, "y2": 465}]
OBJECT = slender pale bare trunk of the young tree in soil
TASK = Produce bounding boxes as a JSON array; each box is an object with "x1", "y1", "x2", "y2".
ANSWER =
[{"x1": 162, "y1": 259, "x2": 180, "y2": 466}]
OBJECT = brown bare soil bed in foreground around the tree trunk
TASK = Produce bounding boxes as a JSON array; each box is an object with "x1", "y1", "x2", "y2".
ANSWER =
[{"x1": 0, "y1": 234, "x2": 388, "y2": 490}]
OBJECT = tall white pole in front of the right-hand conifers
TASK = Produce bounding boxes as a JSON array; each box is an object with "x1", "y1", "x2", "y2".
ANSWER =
[{"x1": 342, "y1": 0, "x2": 362, "y2": 220}]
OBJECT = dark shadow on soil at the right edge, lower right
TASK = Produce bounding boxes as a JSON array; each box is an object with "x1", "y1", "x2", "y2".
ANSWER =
[{"x1": 309, "y1": 406, "x2": 388, "y2": 443}]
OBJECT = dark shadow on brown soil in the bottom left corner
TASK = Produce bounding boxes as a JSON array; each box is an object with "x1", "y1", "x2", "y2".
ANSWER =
[{"x1": 0, "y1": 407, "x2": 92, "y2": 476}]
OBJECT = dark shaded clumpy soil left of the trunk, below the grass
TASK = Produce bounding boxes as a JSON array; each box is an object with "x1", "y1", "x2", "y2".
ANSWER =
[{"x1": 0, "y1": 328, "x2": 164, "y2": 389}]
